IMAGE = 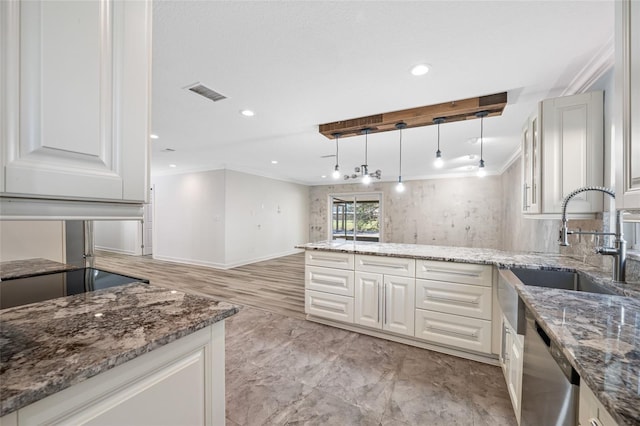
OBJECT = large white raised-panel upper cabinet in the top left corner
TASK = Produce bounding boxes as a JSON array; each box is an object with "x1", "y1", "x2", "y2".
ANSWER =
[{"x1": 0, "y1": 0, "x2": 151, "y2": 203}]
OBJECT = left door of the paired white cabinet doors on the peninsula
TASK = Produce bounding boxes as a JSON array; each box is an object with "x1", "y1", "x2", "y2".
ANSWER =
[{"x1": 354, "y1": 272, "x2": 384, "y2": 328}]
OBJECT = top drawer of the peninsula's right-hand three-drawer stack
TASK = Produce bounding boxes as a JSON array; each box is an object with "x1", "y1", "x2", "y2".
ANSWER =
[{"x1": 416, "y1": 260, "x2": 492, "y2": 287}]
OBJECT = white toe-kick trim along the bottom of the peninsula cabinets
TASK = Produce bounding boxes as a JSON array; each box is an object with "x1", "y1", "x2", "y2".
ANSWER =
[{"x1": 307, "y1": 315, "x2": 500, "y2": 366}]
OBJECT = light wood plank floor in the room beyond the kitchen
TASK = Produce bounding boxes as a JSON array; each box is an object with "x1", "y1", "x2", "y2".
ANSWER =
[{"x1": 95, "y1": 251, "x2": 304, "y2": 319}]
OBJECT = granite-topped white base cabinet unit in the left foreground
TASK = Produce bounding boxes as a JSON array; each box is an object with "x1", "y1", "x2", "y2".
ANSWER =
[{"x1": 0, "y1": 262, "x2": 238, "y2": 426}]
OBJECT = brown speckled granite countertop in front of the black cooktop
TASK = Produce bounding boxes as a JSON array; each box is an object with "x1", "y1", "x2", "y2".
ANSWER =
[{"x1": 0, "y1": 283, "x2": 238, "y2": 416}]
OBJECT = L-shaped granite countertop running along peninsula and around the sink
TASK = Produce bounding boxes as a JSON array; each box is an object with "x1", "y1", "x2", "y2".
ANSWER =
[{"x1": 298, "y1": 241, "x2": 640, "y2": 425}]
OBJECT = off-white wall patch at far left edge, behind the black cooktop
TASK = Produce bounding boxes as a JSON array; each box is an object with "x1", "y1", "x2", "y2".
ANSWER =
[{"x1": 0, "y1": 220, "x2": 65, "y2": 263}]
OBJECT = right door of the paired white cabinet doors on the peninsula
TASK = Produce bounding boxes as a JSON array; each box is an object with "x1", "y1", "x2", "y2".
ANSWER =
[{"x1": 382, "y1": 275, "x2": 415, "y2": 336}]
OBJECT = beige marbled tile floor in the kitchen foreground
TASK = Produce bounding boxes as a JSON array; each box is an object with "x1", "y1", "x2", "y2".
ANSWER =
[{"x1": 226, "y1": 307, "x2": 516, "y2": 426}]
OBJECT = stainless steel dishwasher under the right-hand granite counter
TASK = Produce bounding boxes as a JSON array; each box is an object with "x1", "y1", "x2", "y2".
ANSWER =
[{"x1": 521, "y1": 309, "x2": 580, "y2": 426}]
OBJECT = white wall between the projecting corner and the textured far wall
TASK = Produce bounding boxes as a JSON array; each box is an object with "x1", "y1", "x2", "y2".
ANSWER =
[{"x1": 225, "y1": 170, "x2": 309, "y2": 266}]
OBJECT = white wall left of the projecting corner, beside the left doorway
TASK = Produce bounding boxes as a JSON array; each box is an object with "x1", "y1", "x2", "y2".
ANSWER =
[{"x1": 153, "y1": 170, "x2": 226, "y2": 267}]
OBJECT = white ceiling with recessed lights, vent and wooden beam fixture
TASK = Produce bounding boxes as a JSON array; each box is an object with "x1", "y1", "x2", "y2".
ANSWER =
[{"x1": 151, "y1": 0, "x2": 613, "y2": 185}]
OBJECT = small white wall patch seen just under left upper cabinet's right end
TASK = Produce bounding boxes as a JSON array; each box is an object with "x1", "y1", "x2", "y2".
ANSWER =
[{"x1": 93, "y1": 220, "x2": 142, "y2": 256}]
